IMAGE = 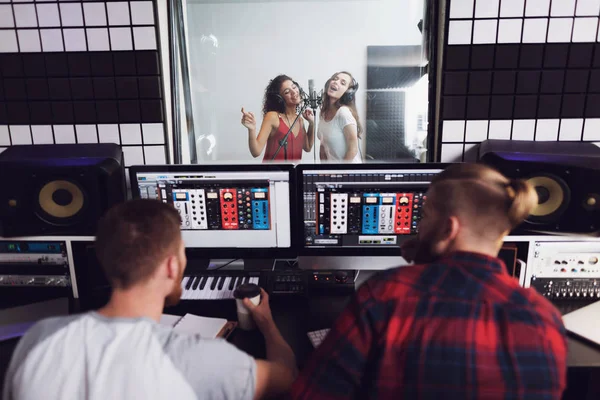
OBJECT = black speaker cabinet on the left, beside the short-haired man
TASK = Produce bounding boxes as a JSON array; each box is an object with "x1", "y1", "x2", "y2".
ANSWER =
[{"x1": 0, "y1": 143, "x2": 126, "y2": 237}]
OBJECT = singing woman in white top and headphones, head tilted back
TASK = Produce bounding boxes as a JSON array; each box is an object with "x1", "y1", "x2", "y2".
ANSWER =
[{"x1": 317, "y1": 71, "x2": 362, "y2": 163}]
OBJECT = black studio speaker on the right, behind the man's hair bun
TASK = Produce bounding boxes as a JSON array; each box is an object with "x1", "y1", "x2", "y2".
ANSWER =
[{"x1": 479, "y1": 140, "x2": 600, "y2": 235}]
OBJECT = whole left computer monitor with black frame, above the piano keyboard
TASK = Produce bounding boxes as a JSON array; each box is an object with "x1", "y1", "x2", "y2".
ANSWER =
[{"x1": 130, "y1": 164, "x2": 297, "y2": 259}]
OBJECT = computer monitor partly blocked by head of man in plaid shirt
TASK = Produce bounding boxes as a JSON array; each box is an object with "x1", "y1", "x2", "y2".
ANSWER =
[{"x1": 297, "y1": 163, "x2": 446, "y2": 256}]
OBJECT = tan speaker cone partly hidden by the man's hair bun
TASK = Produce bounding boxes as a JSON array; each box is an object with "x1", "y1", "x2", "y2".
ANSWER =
[{"x1": 527, "y1": 174, "x2": 571, "y2": 223}]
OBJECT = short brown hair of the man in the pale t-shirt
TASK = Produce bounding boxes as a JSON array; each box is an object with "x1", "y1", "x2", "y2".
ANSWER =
[{"x1": 96, "y1": 199, "x2": 181, "y2": 289}]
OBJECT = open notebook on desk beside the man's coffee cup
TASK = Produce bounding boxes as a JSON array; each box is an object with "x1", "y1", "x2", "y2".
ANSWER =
[{"x1": 160, "y1": 313, "x2": 237, "y2": 339}]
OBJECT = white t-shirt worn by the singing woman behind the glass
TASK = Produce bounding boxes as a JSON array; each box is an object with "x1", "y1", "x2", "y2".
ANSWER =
[{"x1": 317, "y1": 106, "x2": 362, "y2": 163}]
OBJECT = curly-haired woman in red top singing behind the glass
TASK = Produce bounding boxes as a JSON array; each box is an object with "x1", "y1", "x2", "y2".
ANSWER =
[{"x1": 242, "y1": 75, "x2": 315, "y2": 162}]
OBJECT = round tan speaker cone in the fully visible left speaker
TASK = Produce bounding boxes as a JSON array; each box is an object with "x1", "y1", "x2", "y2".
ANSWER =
[{"x1": 38, "y1": 180, "x2": 85, "y2": 224}]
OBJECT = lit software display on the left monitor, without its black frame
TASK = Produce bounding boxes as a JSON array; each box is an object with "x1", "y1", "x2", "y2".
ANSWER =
[{"x1": 136, "y1": 171, "x2": 291, "y2": 248}]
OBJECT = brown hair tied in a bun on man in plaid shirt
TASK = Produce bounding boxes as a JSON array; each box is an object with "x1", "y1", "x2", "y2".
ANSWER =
[{"x1": 427, "y1": 163, "x2": 538, "y2": 235}]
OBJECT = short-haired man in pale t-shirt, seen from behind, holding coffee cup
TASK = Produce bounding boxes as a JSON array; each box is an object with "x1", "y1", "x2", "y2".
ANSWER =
[{"x1": 3, "y1": 200, "x2": 297, "y2": 400}]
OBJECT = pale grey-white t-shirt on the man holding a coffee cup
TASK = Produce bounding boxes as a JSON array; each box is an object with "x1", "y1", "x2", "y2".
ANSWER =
[{"x1": 2, "y1": 312, "x2": 256, "y2": 400}]
